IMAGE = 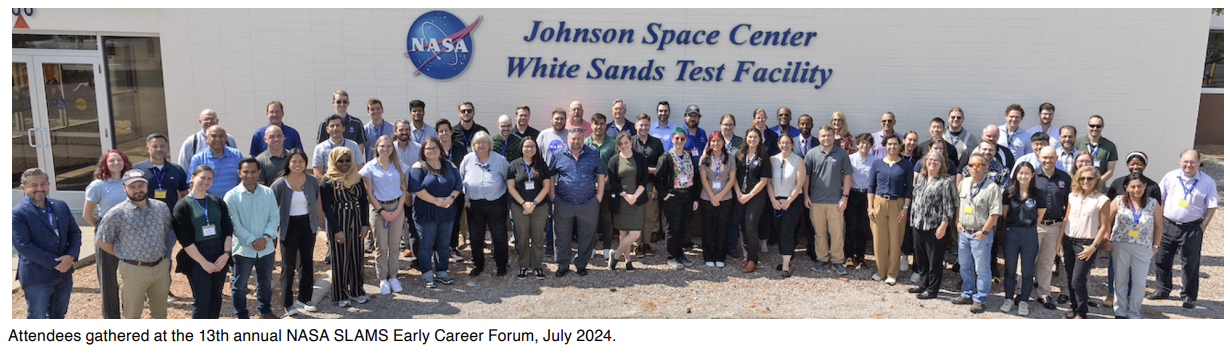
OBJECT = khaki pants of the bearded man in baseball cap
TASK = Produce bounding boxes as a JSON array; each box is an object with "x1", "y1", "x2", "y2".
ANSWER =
[{"x1": 117, "y1": 259, "x2": 171, "y2": 318}]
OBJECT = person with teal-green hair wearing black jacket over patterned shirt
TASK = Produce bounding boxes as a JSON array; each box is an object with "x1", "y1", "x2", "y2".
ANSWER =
[{"x1": 653, "y1": 128, "x2": 700, "y2": 270}]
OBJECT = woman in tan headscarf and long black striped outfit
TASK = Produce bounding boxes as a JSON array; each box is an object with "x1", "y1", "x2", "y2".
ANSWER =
[{"x1": 320, "y1": 146, "x2": 370, "y2": 307}]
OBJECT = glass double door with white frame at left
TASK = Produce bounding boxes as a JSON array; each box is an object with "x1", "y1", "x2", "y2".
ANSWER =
[{"x1": 12, "y1": 52, "x2": 112, "y2": 208}]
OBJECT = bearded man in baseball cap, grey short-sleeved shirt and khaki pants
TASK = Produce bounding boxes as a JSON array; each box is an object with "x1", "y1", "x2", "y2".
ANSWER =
[{"x1": 95, "y1": 170, "x2": 171, "y2": 318}]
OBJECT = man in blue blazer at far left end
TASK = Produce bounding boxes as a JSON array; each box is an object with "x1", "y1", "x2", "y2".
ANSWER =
[{"x1": 12, "y1": 167, "x2": 81, "y2": 318}]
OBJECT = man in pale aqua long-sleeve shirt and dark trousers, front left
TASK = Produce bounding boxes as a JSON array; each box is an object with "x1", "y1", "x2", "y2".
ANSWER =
[{"x1": 223, "y1": 157, "x2": 280, "y2": 318}]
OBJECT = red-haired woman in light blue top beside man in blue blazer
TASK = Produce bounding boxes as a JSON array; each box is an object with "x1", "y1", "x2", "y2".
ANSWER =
[{"x1": 81, "y1": 150, "x2": 133, "y2": 318}]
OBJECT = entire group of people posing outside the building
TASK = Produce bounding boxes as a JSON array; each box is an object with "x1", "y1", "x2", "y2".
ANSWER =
[{"x1": 14, "y1": 91, "x2": 1218, "y2": 318}]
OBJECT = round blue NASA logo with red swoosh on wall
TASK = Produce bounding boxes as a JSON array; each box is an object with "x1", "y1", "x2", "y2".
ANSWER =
[{"x1": 406, "y1": 10, "x2": 482, "y2": 80}]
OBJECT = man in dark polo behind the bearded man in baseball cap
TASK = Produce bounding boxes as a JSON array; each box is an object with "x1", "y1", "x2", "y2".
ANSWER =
[{"x1": 133, "y1": 133, "x2": 188, "y2": 301}]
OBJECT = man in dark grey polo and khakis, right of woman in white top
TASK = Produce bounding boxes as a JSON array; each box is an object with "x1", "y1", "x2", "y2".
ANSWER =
[{"x1": 800, "y1": 124, "x2": 854, "y2": 275}]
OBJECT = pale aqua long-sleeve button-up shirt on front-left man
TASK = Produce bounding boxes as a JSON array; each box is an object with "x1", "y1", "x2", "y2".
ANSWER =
[{"x1": 223, "y1": 184, "x2": 282, "y2": 258}]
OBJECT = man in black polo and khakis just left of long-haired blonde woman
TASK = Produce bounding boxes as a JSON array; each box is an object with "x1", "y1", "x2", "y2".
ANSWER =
[{"x1": 1033, "y1": 146, "x2": 1073, "y2": 310}]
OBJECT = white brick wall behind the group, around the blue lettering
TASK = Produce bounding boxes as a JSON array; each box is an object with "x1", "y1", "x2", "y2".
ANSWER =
[{"x1": 19, "y1": 9, "x2": 1209, "y2": 177}]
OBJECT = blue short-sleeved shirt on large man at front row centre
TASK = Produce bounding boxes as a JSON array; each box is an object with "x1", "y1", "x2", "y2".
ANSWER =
[{"x1": 546, "y1": 146, "x2": 606, "y2": 206}]
